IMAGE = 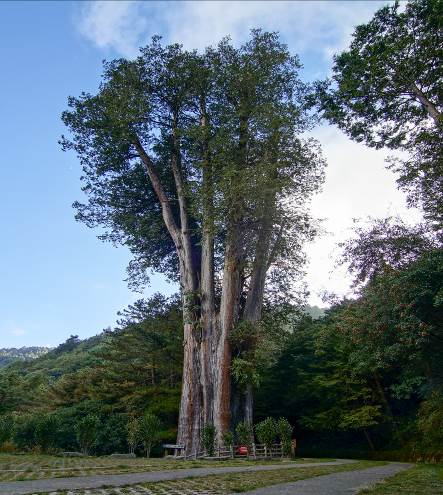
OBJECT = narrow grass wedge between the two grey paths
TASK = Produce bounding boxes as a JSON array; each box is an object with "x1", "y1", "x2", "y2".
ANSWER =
[{"x1": 44, "y1": 461, "x2": 386, "y2": 495}]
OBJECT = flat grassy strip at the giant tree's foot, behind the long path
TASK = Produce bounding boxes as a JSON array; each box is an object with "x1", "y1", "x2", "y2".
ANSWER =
[{"x1": 0, "y1": 454, "x2": 329, "y2": 481}]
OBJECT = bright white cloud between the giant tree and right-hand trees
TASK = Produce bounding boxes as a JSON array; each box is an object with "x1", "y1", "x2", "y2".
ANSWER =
[{"x1": 307, "y1": 126, "x2": 421, "y2": 305}]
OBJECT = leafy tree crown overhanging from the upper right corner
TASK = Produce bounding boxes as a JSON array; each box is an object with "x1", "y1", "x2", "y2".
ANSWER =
[{"x1": 318, "y1": 0, "x2": 443, "y2": 231}]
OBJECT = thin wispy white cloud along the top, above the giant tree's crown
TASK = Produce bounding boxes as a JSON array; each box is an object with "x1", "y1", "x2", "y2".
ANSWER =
[{"x1": 77, "y1": 1, "x2": 392, "y2": 62}]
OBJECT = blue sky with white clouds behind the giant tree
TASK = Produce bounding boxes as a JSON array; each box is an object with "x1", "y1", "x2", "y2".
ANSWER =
[{"x1": 0, "y1": 1, "x2": 415, "y2": 348}]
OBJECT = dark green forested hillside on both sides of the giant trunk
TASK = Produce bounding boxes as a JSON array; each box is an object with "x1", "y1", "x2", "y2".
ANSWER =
[{"x1": 0, "y1": 280, "x2": 443, "y2": 458}]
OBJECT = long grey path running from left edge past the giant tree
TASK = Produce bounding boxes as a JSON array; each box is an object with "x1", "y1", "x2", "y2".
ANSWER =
[{"x1": 0, "y1": 459, "x2": 356, "y2": 495}]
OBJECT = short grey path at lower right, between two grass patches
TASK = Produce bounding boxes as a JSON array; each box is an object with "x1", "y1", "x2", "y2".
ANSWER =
[{"x1": 238, "y1": 462, "x2": 413, "y2": 495}]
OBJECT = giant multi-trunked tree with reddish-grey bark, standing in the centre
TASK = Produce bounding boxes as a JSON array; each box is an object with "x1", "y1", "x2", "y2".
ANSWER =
[{"x1": 62, "y1": 31, "x2": 324, "y2": 452}]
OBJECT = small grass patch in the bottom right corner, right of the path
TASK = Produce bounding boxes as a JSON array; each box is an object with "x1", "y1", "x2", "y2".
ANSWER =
[{"x1": 359, "y1": 464, "x2": 443, "y2": 495}]
